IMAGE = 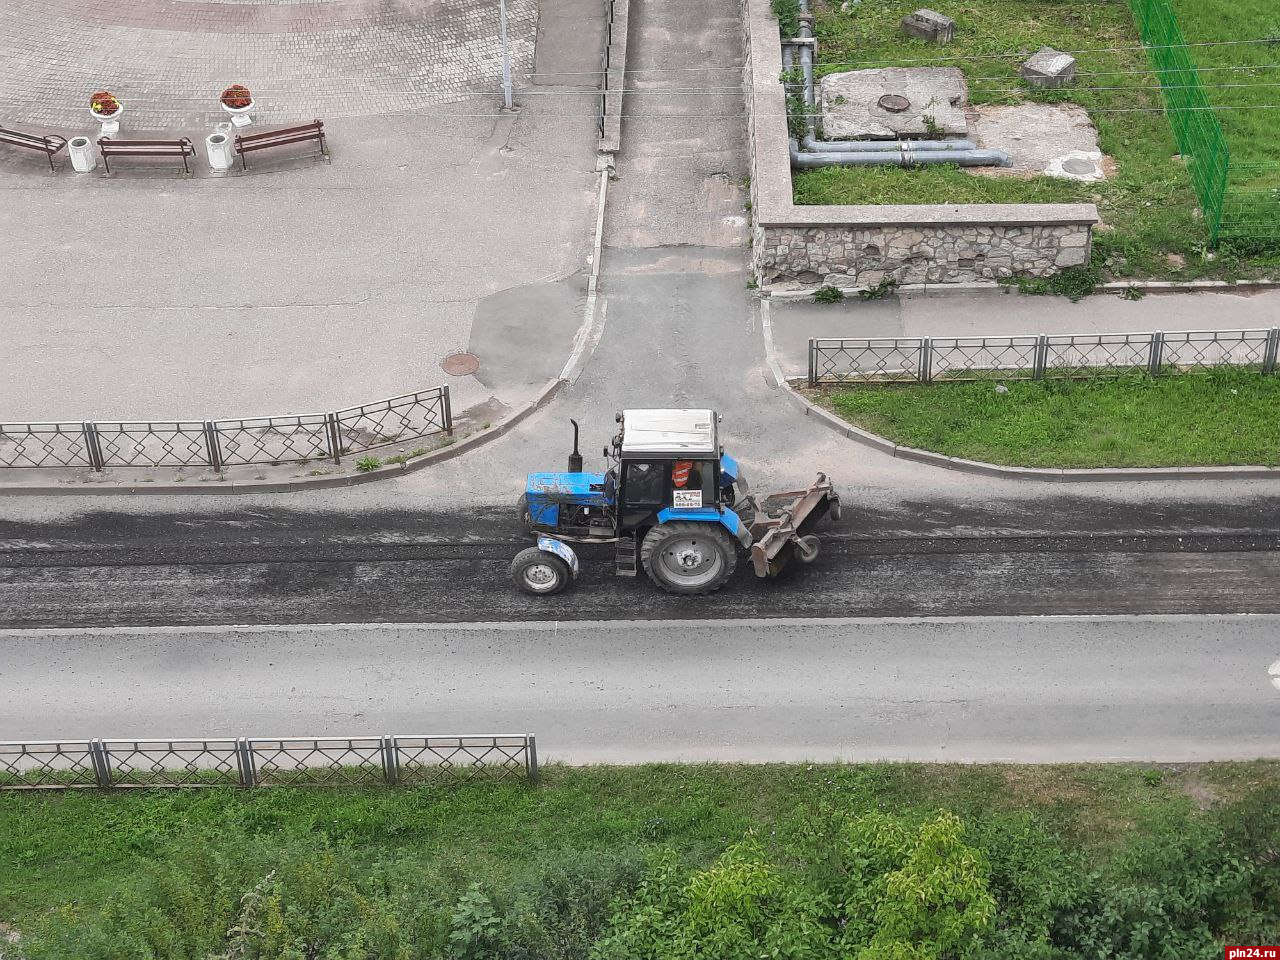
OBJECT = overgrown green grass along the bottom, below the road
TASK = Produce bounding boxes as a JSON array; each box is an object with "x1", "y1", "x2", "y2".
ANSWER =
[{"x1": 0, "y1": 762, "x2": 1280, "y2": 960}]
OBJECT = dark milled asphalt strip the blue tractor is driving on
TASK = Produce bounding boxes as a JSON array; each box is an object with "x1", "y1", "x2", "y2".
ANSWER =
[{"x1": 0, "y1": 497, "x2": 1280, "y2": 627}]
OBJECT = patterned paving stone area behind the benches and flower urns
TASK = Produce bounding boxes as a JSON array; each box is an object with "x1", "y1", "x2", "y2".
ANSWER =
[{"x1": 0, "y1": 0, "x2": 538, "y2": 136}]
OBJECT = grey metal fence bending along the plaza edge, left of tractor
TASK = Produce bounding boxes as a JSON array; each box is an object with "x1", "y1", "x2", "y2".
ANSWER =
[{"x1": 0, "y1": 387, "x2": 453, "y2": 471}]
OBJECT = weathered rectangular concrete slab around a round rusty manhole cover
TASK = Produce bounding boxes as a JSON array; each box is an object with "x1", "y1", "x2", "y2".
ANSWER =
[{"x1": 819, "y1": 67, "x2": 969, "y2": 140}]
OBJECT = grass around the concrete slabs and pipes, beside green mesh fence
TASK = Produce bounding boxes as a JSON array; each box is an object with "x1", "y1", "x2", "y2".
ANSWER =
[{"x1": 794, "y1": 0, "x2": 1280, "y2": 279}]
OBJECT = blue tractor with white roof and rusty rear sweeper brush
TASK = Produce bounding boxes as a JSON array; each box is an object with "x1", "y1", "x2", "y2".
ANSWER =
[{"x1": 511, "y1": 410, "x2": 840, "y2": 596}]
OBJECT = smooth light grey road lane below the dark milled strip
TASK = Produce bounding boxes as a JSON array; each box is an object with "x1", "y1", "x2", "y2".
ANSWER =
[{"x1": 0, "y1": 616, "x2": 1280, "y2": 763}]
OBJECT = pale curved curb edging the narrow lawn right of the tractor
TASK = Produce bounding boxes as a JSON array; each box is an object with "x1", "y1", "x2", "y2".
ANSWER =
[{"x1": 760, "y1": 298, "x2": 1280, "y2": 483}]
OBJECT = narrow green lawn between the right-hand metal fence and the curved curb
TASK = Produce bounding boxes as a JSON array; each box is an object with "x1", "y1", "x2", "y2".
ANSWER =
[{"x1": 819, "y1": 370, "x2": 1280, "y2": 467}]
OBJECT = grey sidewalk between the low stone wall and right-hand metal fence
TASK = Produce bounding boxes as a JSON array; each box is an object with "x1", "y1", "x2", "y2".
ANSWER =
[{"x1": 771, "y1": 291, "x2": 1280, "y2": 378}]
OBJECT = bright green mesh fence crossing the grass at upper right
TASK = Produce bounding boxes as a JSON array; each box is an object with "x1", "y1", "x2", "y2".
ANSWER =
[{"x1": 1130, "y1": 0, "x2": 1280, "y2": 248}]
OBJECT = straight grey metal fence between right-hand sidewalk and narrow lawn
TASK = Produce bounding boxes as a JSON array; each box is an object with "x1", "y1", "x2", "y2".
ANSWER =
[{"x1": 809, "y1": 328, "x2": 1280, "y2": 387}]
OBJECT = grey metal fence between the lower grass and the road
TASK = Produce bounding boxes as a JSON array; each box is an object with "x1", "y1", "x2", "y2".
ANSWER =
[{"x1": 0, "y1": 733, "x2": 538, "y2": 790}]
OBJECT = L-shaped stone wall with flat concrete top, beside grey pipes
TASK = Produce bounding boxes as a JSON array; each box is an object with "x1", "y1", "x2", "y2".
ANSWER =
[{"x1": 742, "y1": 0, "x2": 1098, "y2": 287}]
